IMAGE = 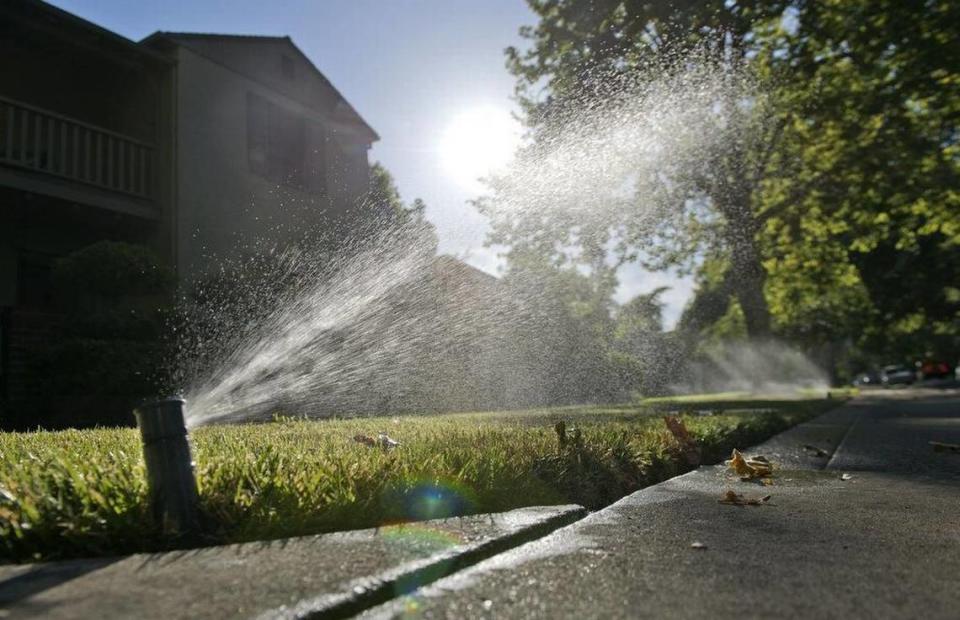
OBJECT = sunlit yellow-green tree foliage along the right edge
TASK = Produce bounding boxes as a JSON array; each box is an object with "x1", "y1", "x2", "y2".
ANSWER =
[{"x1": 759, "y1": 0, "x2": 960, "y2": 360}]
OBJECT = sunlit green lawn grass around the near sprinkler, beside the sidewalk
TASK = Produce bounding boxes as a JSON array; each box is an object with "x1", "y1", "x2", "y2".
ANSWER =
[{"x1": 0, "y1": 399, "x2": 837, "y2": 561}]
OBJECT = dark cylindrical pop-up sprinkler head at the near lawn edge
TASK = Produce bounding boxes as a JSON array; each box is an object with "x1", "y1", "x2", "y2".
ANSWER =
[{"x1": 133, "y1": 398, "x2": 199, "y2": 535}]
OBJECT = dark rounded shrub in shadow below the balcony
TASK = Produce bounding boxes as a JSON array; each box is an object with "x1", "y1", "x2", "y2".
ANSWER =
[{"x1": 21, "y1": 241, "x2": 175, "y2": 427}]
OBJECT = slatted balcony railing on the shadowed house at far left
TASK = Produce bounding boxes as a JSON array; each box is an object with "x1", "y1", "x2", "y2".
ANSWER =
[{"x1": 0, "y1": 97, "x2": 156, "y2": 198}]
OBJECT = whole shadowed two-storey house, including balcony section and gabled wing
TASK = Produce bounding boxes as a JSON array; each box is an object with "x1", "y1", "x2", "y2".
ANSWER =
[{"x1": 0, "y1": 0, "x2": 378, "y2": 416}]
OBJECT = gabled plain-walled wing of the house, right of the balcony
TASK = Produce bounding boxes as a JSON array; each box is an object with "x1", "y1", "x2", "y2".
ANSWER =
[{"x1": 141, "y1": 32, "x2": 378, "y2": 273}]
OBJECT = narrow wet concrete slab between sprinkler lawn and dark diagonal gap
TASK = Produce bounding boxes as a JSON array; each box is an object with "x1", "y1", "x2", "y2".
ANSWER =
[{"x1": 0, "y1": 506, "x2": 586, "y2": 620}]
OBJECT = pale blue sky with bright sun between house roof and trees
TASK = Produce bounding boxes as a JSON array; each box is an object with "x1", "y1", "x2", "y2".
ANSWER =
[{"x1": 52, "y1": 0, "x2": 692, "y2": 327}]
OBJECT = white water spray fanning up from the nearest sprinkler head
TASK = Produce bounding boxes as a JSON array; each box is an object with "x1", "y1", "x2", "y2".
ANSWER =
[{"x1": 176, "y1": 59, "x2": 776, "y2": 426}]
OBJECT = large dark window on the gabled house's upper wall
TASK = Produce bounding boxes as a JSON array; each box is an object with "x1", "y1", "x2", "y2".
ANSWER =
[{"x1": 247, "y1": 93, "x2": 306, "y2": 187}]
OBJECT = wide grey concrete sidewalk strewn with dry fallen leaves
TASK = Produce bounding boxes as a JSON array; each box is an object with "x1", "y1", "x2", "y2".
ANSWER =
[{"x1": 366, "y1": 391, "x2": 960, "y2": 619}]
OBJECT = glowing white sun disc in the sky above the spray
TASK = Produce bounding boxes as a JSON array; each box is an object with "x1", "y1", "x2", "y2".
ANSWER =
[{"x1": 439, "y1": 106, "x2": 520, "y2": 190}]
